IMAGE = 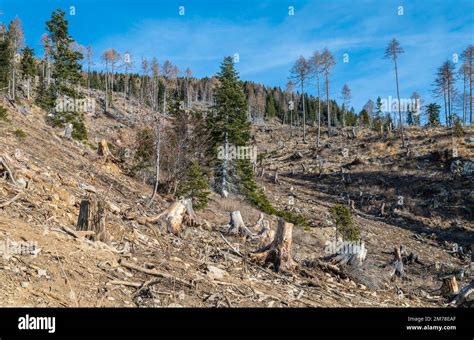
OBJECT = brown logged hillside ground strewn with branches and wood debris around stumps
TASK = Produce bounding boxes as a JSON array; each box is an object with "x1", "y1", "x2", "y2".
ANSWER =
[{"x1": 0, "y1": 93, "x2": 474, "y2": 307}]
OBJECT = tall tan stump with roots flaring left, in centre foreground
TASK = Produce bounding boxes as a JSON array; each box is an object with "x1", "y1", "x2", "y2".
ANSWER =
[{"x1": 252, "y1": 218, "x2": 296, "y2": 272}]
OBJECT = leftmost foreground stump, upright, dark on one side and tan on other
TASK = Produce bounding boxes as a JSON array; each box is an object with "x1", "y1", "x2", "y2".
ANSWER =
[{"x1": 76, "y1": 199, "x2": 107, "y2": 242}]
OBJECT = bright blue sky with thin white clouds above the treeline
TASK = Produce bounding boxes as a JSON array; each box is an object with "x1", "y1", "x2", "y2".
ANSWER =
[{"x1": 0, "y1": 0, "x2": 474, "y2": 114}]
